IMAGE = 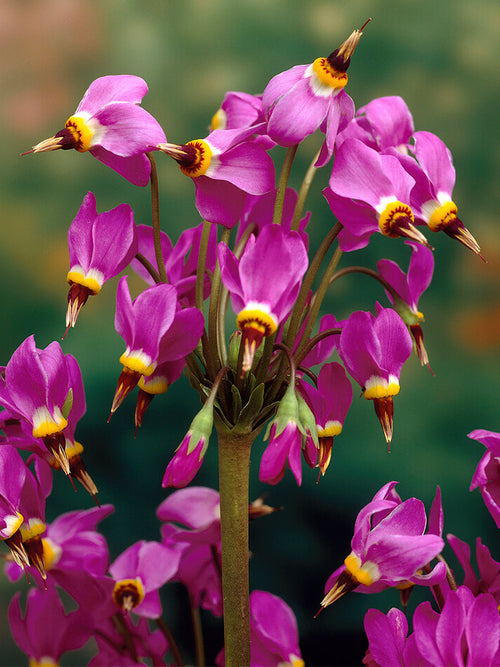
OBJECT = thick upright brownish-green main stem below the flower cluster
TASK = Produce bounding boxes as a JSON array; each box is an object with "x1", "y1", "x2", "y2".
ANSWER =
[{"x1": 218, "y1": 428, "x2": 255, "y2": 667}]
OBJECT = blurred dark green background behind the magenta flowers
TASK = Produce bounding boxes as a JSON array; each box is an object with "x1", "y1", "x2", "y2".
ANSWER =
[{"x1": 0, "y1": 0, "x2": 500, "y2": 665}]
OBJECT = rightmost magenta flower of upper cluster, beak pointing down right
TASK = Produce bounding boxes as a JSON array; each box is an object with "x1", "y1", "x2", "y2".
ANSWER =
[{"x1": 398, "y1": 132, "x2": 481, "y2": 257}]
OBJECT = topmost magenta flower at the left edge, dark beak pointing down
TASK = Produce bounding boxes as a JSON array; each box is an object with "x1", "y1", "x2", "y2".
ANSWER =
[{"x1": 0, "y1": 336, "x2": 71, "y2": 475}]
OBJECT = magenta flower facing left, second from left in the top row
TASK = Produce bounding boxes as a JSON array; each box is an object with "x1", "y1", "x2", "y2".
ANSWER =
[{"x1": 158, "y1": 128, "x2": 274, "y2": 227}]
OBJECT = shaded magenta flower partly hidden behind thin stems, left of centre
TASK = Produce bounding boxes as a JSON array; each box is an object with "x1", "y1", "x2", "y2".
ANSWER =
[{"x1": 131, "y1": 224, "x2": 217, "y2": 307}]
